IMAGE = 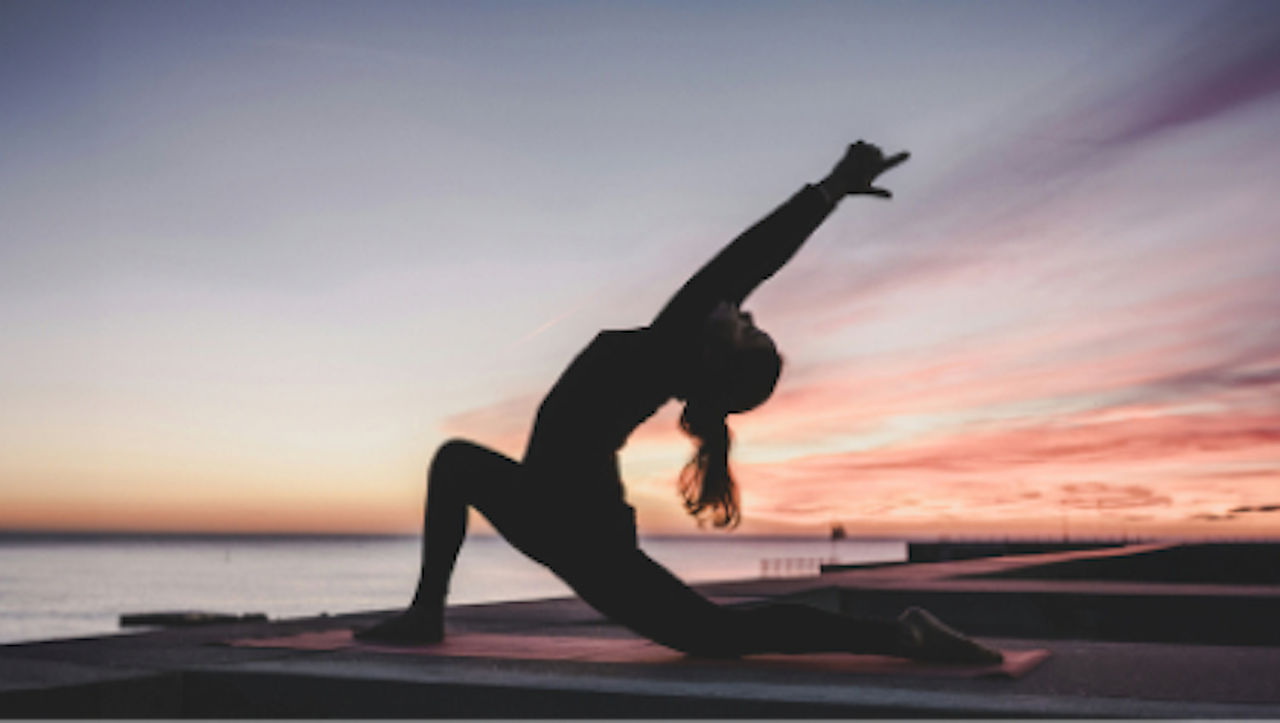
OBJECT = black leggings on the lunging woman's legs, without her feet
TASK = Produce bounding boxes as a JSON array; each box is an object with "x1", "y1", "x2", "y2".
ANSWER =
[{"x1": 413, "y1": 441, "x2": 899, "y2": 656}]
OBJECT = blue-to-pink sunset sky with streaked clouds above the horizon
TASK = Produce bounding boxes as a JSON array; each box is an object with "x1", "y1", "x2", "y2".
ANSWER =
[{"x1": 0, "y1": 0, "x2": 1280, "y2": 537}]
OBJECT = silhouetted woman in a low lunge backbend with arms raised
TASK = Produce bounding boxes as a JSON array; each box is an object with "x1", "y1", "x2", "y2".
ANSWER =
[{"x1": 358, "y1": 141, "x2": 1000, "y2": 662}]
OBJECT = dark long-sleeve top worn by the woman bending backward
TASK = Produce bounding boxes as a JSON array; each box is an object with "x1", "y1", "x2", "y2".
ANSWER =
[{"x1": 522, "y1": 186, "x2": 833, "y2": 539}]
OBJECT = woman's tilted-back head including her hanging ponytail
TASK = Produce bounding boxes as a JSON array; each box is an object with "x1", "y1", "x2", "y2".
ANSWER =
[{"x1": 680, "y1": 303, "x2": 782, "y2": 527}]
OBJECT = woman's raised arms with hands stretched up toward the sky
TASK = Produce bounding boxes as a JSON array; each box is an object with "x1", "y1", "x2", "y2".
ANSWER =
[{"x1": 650, "y1": 141, "x2": 909, "y2": 337}]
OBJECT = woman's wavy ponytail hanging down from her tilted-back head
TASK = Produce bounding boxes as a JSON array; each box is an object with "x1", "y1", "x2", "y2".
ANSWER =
[{"x1": 680, "y1": 404, "x2": 741, "y2": 527}]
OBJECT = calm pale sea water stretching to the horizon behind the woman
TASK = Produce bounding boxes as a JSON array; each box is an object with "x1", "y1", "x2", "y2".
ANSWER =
[{"x1": 0, "y1": 536, "x2": 906, "y2": 644}]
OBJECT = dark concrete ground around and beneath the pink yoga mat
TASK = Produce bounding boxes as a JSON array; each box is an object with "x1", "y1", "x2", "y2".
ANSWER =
[{"x1": 0, "y1": 545, "x2": 1280, "y2": 718}]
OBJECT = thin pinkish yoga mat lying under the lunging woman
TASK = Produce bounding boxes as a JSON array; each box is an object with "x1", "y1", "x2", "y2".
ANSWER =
[{"x1": 227, "y1": 630, "x2": 1048, "y2": 678}]
